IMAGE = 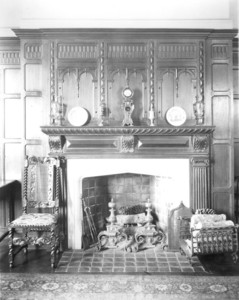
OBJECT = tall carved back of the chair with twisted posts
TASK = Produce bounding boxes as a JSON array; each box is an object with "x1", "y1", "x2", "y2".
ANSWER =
[{"x1": 23, "y1": 156, "x2": 61, "y2": 213}]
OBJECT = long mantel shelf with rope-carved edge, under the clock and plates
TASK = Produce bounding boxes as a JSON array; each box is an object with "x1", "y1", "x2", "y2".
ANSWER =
[{"x1": 41, "y1": 126, "x2": 215, "y2": 136}]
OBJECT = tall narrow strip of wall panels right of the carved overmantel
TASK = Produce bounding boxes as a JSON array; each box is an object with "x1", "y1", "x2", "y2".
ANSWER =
[{"x1": 207, "y1": 37, "x2": 234, "y2": 215}]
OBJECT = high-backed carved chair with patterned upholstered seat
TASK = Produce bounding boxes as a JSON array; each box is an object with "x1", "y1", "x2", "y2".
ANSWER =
[{"x1": 8, "y1": 156, "x2": 64, "y2": 268}]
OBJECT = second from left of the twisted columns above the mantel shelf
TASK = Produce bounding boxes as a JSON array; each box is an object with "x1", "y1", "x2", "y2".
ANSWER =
[{"x1": 98, "y1": 43, "x2": 105, "y2": 126}]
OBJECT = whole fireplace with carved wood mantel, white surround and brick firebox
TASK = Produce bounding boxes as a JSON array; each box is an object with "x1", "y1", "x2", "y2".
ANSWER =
[{"x1": 42, "y1": 126, "x2": 214, "y2": 249}]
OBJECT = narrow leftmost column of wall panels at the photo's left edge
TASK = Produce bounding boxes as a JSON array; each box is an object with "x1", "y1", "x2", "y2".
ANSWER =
[{"x1": 0, "y1": 40, "x2": 21, "y2": 180}]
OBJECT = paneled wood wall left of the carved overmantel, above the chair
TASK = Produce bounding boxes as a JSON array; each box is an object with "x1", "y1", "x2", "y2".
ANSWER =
[{"x1": 0, "y1": 39, "x2": 49, "y2": 181}]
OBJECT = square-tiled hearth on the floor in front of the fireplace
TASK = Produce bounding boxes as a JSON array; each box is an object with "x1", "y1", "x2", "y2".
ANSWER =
[{"x1": 55, "y1": 246, "x2": 206, "y2": 274}]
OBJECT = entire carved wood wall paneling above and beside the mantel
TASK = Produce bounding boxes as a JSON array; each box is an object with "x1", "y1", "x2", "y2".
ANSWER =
[{"x1": 0, "y1": 29, "x2": 239, "y2": 216}]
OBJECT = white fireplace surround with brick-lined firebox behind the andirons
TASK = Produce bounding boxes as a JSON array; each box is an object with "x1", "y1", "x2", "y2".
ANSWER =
[{"x1": 67, "y1": 159, "x2": 190, "y2": 249}]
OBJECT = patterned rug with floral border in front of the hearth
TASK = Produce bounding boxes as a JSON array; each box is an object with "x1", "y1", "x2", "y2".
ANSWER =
[{"x1": 0, "y1": 273, "x2": 239, "y2": 300}]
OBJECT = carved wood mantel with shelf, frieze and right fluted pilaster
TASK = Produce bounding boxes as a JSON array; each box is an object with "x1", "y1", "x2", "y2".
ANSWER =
[{"x1": 41, "y1": 126, "x2": 215, "y2": 209}]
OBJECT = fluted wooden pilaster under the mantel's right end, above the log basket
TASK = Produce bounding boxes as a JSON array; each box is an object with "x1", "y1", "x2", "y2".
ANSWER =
[{"x1": 191, "y1": 157, "x2": 210, "y2": 210}]
